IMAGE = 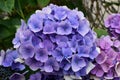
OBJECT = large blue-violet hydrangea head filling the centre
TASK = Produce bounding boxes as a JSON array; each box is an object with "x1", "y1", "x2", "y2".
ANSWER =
[{"x1": 13, "y1": 4, "x2": 98, "y2": 76}]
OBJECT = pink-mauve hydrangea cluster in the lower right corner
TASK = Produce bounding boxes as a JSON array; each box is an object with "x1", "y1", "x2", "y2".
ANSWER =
[{"x1": 91, "y1": 36, "x2": 120, "y2": 79}]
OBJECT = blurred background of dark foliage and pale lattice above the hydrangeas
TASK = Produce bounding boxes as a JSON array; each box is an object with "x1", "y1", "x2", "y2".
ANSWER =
[{"x1": 0, "y1": 0, "x2": 120, "y2": 50}]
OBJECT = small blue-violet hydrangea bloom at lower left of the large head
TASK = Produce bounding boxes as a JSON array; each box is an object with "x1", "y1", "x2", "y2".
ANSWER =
[{"x1": 1, "y1": 49, "x2": 25, "y2": 71}]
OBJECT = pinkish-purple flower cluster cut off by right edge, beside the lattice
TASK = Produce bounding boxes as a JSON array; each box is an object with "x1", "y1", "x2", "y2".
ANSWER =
[{"x1": 105, "y1": 14, "x2": 120, "y2": 38}]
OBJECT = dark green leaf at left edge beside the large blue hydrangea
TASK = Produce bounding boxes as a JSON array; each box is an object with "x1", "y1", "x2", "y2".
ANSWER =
[{"x1": 0, "y1": 18, "x2": 20, "y2": 41}]
